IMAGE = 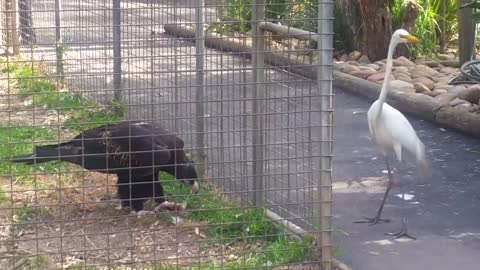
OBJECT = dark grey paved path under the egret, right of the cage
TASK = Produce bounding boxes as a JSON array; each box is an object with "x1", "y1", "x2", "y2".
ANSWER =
[{"x1": 334, "y1": 87, "x2": 480, "y2": 270}]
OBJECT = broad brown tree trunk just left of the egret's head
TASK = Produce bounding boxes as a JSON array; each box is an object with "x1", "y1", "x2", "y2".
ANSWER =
[{"x1": 360, "y1": 0, "x2": 392, "y2": 61}]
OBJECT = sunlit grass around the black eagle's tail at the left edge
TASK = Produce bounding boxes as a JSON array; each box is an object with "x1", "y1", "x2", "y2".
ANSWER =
[{"x1": 0, "y1": 58, "x2": 122, "y2": 180}]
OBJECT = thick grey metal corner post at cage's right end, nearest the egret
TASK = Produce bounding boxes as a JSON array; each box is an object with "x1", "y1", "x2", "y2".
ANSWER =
[{"x1": 317, "y1": 0, "x2": 334, "y2": 270}]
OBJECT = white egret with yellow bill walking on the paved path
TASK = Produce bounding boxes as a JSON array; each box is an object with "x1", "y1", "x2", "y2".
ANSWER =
[{"x1": 356, "y1": 29, "x2": 426, "y2": 239}]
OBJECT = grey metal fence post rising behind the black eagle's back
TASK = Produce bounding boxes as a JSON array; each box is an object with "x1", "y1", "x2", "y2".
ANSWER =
[{"x1": 112, "y1": 0, "x2": 122, "y2": 102}]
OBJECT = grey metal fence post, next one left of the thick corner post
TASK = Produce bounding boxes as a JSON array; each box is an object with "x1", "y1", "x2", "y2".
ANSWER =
[{"x1": 252, "y1": 0, "x2": 266, "y2": 206}]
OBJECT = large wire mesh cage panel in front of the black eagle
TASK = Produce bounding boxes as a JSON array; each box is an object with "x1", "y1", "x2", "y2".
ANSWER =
[{"x1": 0, "y1": 0, "x2": 333, "y2": 269}]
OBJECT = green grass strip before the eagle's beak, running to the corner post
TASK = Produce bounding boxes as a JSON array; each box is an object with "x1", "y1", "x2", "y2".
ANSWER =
[{"x1": 160, "y1": 173, "x2": 312, "y2": 270}]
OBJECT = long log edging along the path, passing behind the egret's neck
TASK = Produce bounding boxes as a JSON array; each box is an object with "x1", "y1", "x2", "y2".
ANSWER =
[{"x1": 164, "y1": 24, "x2": 480, "y2": 137}]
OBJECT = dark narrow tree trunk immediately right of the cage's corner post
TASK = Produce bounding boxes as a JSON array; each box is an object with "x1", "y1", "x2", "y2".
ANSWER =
[{"x1": 335, "y1": 0, "x2": 362, "y2": 51}]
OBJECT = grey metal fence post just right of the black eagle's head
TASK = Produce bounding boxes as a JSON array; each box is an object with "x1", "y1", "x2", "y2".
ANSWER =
[{"x1": 195, "y1": 0, "x2": 205, "y2": 176}]
